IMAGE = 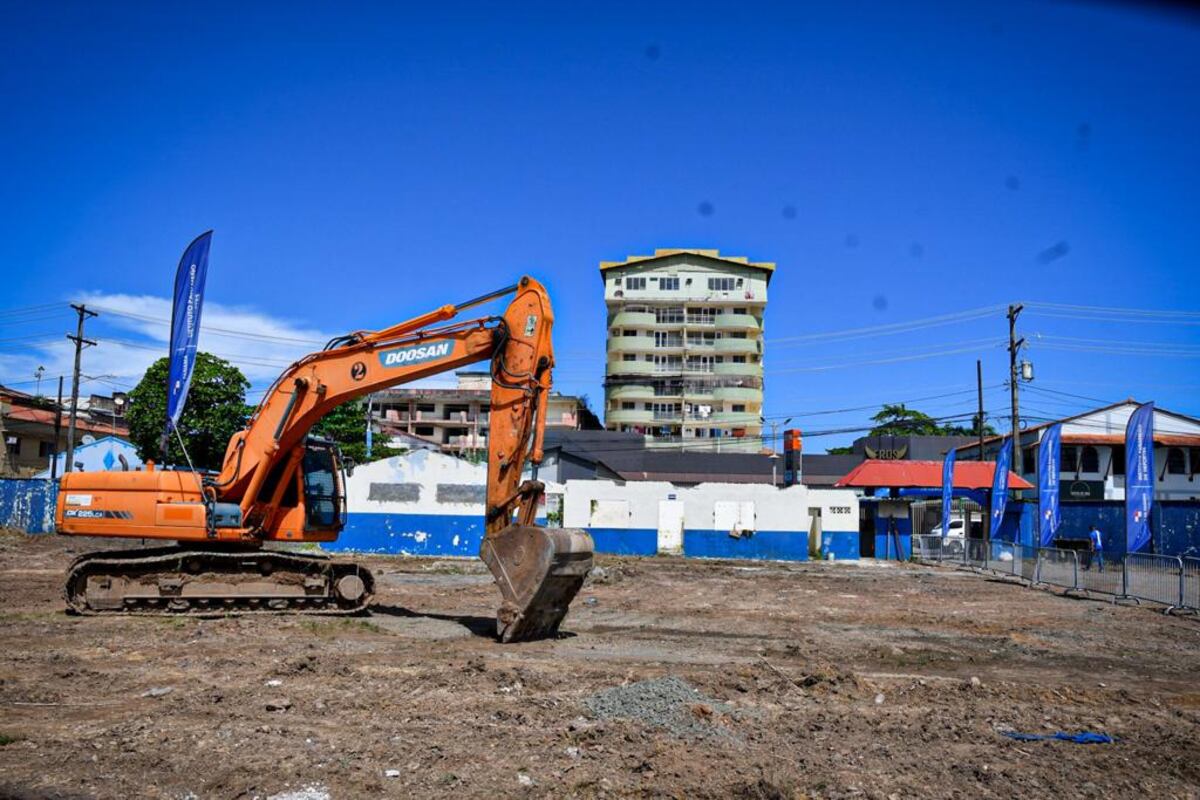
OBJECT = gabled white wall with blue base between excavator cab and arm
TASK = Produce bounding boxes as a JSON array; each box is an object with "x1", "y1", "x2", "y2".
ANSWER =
[{"x1": 323, "y1": 450, "x2": 562, "y2": 558}]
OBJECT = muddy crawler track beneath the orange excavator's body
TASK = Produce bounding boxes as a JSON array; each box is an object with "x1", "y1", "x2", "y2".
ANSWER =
[{"x1": 64, "y1": 547, "x2": 374, "y2": 615}]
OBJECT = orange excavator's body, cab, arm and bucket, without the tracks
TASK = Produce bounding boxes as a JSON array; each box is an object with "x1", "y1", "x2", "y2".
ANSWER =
[{"x1": 59, "y1": 277, "x2": 592, "y2": 640}]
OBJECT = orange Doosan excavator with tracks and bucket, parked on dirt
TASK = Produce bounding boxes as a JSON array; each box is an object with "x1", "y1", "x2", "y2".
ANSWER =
[{"x1": 56, "y1": 277, "x2": 593, "y2": 642}]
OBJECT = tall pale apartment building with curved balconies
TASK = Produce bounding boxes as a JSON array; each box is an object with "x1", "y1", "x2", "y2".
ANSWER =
[{"x1": 600, "y1": 249, "x2": 775, "y2": 451}]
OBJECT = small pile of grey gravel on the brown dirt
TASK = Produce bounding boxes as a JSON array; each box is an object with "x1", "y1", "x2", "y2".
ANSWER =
[{"x1": 583, "y1": 675, "x2": 733, "y2": 739}]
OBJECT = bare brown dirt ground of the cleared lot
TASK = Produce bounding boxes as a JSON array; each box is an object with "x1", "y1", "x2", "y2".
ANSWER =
[{"x1": 0, "y1": 534, "x2": 1200, "y2": 800}]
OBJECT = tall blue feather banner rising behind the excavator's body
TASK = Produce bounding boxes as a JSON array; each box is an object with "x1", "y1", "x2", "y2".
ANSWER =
[{"x1": 163, "y1": 230, "x2": 212, "y2": 449}]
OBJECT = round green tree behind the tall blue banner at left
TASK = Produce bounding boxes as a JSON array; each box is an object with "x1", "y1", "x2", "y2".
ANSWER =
[{"x1": 126, "y1": 353, "x2": 250, "y2": 469}]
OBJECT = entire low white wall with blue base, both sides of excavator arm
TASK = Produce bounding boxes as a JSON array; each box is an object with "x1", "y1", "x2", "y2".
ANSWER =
[{"x1": 325, "y1": 451, "x2": 858, "y2": 561}]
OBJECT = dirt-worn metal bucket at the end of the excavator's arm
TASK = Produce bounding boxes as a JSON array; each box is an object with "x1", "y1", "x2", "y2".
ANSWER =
[{"x1": 479, "y1": 524, "x2": 593, "y2": 642}]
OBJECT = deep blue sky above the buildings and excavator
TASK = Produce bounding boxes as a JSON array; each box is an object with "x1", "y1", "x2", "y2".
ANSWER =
[{"x1": 0, "y1": 2, "x2": 1200, "y2": 450}]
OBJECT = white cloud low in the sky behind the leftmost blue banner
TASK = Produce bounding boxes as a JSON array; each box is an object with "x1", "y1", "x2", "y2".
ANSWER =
[{"x1": 0, "y1": 291, "x2": 454, "y2": 403}]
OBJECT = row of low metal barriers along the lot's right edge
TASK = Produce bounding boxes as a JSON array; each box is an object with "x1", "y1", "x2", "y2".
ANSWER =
[{"x1": 912, "y1": 535, "x2": 1200, "y2": 612}]
